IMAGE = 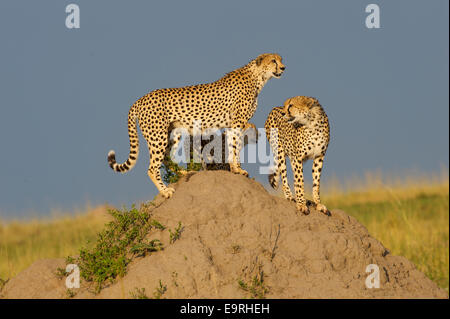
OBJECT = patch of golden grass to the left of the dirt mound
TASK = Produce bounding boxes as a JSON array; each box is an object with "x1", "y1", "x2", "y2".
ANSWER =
[{"x1": 0, "y1": 207, "x2": 108, "y2": 280}]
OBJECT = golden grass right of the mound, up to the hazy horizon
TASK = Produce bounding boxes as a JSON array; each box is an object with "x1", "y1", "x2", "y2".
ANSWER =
[{"x1": 322, "y1": 170, "x2": 449, "y2": 291}]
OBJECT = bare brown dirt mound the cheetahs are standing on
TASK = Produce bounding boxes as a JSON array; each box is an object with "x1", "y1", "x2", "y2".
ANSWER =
[{"x1": 3, "y1": 171, "x2": 448, "y2": 298}]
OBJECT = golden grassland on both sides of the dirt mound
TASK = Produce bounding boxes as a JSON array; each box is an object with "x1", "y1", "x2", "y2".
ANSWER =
[{"x1": 0, "y1": 172, "x2": 449, "y2": 292}]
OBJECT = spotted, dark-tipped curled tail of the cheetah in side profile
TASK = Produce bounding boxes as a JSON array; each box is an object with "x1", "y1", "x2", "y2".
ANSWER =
[{"x1": 108, "y1": 105, "x2": 139, "y2": 173}]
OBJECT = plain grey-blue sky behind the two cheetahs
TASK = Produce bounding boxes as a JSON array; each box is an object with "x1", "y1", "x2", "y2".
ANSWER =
[{"x1": 0, "y1": 0, "x2": 449, "y2": 217}]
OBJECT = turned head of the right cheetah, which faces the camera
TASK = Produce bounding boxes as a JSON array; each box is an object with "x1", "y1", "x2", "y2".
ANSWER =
[{"x1": 283, "y1": 96, "x2": 321, "y2": 127}]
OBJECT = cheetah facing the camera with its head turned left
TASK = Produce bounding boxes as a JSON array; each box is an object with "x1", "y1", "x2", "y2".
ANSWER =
[{"x1": 264, "y1": 96, "x2": 330, "y2": 215}]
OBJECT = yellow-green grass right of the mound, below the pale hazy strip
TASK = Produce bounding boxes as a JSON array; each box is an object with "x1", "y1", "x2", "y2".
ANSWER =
[{"x1": 324, "y1": 185, "x2": 449, "y2": 291}]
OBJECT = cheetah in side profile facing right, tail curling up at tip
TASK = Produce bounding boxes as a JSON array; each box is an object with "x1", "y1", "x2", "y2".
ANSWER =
[{"x1": 108, "y1": 53, "x2": 285, "y2": 198}]
